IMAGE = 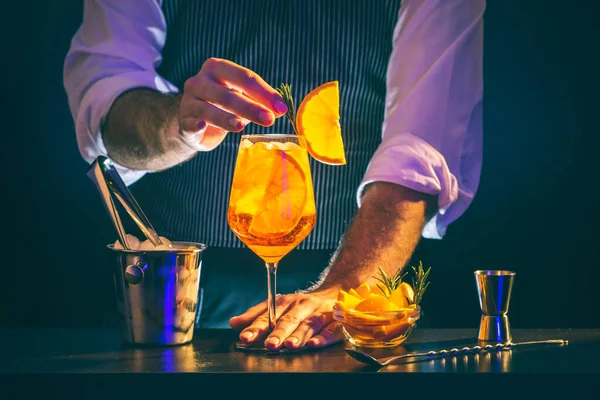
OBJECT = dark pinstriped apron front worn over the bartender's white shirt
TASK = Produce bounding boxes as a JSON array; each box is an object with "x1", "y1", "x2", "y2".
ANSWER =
[{"x1": 132, "y1": 0, "x2": 400, "y2": 324}]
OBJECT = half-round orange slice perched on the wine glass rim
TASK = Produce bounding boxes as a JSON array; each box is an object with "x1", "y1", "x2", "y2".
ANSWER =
[{"x1": 296, "y1": 81, "x2": 346, "y2": 165}]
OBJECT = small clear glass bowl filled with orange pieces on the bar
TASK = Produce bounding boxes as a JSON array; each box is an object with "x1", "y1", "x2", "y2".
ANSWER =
[{"x1": 333, "y1": 306, "x2": 421, "y2": 347}]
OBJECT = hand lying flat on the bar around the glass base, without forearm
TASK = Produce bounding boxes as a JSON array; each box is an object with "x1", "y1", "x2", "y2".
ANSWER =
[{"x1": 229, "y1": 289, "x2": 343, "y2": 350}]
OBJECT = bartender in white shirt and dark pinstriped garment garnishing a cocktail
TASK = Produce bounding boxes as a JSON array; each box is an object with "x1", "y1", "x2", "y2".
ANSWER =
[{"x1": 64, "y1": 0, "x2": 485, "y2": 350}]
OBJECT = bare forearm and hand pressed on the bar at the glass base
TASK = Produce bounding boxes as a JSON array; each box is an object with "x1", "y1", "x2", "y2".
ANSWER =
[{"x1": 229, "y1": 182, "x2": 436, "y2": 350}]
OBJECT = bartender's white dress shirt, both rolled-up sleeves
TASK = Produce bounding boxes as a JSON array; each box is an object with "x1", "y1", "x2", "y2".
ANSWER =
[{"x1": 64, "y1": 0, "x2": 485, "y2": 239}]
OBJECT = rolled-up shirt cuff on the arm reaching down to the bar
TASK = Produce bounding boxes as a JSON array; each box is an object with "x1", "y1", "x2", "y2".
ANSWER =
[{"x1": 356, "y1": 132, "x2": 464, "y2": 239}]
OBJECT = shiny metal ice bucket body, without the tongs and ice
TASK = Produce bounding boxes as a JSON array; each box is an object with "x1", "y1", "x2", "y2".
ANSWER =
[{"x1": 108, "y1": 242, "x2": 206, "y2": 345}]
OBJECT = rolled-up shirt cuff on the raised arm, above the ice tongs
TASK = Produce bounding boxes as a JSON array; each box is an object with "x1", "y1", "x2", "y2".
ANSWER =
[{"x1": 76, "y1": 71, "x2": 178, "y2": 186}]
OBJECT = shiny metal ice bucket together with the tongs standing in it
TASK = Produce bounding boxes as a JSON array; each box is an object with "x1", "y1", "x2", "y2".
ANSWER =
[{"x1": 87, "y1": 156, "x2": 206, "y2": 345}]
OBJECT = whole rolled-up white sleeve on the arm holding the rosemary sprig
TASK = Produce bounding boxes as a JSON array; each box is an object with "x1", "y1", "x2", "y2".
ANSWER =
[{"x1": 63, "y1": 0, "x2": 178, "y2": 185}]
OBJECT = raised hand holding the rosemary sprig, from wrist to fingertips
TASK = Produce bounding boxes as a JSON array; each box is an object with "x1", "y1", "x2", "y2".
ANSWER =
[{"x1": 179, "y1": 58, "x2": 287, "y2": 151}]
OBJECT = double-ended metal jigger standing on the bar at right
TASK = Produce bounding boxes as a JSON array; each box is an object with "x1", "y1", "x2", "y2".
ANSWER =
[{"x1": 475, "y1": 270, "x2": 515, "y2": 343}]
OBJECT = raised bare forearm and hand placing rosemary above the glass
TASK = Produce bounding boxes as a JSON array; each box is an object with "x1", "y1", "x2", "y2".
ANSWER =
[{"x1": 103, "y1": 58, "x2": 287, "y2": 171}]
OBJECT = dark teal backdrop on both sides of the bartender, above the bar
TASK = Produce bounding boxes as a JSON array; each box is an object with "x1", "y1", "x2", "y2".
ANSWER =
[{"x1": 0, "y1": 0, "x2": 600, "y2": 328}]
